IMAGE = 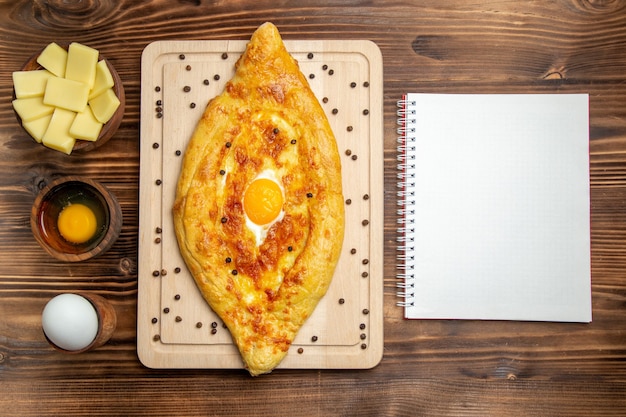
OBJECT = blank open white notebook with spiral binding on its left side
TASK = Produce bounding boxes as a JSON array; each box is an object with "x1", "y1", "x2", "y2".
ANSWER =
[{"x1": 397, "y1": 94, "x2": 592, "y2": 322}]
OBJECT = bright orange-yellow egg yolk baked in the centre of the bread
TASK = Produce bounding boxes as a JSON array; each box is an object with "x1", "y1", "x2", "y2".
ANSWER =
[{"x1": 243, "y1": 178, "x2": 283, "y2": 225}]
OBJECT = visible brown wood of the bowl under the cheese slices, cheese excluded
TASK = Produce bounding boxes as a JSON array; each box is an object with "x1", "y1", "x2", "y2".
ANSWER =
[{"x1": 13, "y1": 45, "x2": 126, "y2": 152}]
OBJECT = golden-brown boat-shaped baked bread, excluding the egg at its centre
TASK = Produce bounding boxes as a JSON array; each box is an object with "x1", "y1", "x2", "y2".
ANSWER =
[{"x1": 173, "y1": 23, "x2": 344, "y2": 375}]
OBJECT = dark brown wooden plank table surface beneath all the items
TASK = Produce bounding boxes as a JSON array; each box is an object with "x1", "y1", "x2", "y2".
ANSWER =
[{"x1": 0, "y1": 0, "x2": 626, "y2": 416}]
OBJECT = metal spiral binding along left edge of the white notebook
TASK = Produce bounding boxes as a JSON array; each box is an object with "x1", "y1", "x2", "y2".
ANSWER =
[{"x1": 396, "y1": 99, "x2": 416, "y2": 307}]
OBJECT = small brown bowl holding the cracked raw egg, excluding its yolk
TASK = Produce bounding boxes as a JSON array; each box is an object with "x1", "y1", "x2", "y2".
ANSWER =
[{"x1": 30, "y1": 176, "x2": 122, "y2": 262}]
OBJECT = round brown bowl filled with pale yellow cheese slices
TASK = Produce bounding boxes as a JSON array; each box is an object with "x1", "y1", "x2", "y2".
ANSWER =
[{"x1": 12, "y1": 42, "x2": 126, "y2": 155}]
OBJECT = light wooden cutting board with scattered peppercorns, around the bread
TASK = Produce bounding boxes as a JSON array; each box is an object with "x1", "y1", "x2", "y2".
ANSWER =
[{"x1": 137, "y1": 40, "x2": 384, "y2": 369}]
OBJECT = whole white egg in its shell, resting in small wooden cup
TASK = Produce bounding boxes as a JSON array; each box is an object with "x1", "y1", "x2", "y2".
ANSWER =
[{"x1": 41, "y1": 294, "x2": 98, "y2": 350}]
